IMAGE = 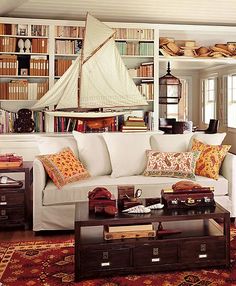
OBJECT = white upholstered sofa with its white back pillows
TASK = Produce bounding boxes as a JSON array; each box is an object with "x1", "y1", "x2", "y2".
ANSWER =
[{"x1": 33, "y1": 132, "x2": 236, "y2": 231}]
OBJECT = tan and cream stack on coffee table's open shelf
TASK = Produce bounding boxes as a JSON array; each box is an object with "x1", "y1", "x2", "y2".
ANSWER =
[{"x1": 104, "y1": 223, "x2": 156, "y2": 240}]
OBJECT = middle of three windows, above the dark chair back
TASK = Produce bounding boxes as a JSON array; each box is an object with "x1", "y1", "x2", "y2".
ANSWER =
[{"x1": 202, "y1": 77, "x2": 217, "y2": 124}]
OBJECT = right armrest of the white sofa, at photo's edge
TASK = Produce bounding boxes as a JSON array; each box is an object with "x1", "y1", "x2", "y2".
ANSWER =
[{"x1": 220, "y1": 153, "x2": 236, "y2": 217}]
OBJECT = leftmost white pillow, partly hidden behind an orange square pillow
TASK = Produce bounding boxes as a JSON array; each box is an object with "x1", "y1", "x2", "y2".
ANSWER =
[{"x1": 37, "y1": 136, "x2": 79, "y2": 158}]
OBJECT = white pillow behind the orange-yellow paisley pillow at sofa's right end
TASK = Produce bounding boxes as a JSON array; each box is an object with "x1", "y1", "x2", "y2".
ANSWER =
[{"x1": 188, "y1": 132, "x2": 226, "y2": 150}]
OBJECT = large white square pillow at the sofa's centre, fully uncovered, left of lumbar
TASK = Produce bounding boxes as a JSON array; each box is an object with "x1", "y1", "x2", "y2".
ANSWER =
[{"x1": 103, "y1": 133, "x2": 151, "y2": 177}]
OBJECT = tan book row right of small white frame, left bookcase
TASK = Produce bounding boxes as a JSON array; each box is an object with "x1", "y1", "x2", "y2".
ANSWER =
[{"x1": 29, "y1": 56, "x2": 48, "y2": 76}]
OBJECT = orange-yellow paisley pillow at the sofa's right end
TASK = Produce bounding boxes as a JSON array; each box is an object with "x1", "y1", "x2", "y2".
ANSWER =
[{"x1": 192, "y1": 139, "x2": 231, "y2": 180}]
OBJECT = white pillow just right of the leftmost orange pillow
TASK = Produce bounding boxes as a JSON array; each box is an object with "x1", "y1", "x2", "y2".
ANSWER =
[{"x1": 73, "y1": 131, "x2": 111, "y2": 176}]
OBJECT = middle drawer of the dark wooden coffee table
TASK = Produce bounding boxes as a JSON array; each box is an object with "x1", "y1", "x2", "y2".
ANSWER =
[{"x1": 133, "y1": 243, "x2": 178, "y2": 266}]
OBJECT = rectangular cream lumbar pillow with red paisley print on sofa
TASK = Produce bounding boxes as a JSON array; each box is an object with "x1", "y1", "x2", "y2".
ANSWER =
[{"x1": 143, "y1": 150, "x2": 200, "y2": 179}]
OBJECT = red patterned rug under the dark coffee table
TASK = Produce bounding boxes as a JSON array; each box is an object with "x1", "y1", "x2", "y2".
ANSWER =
[{"x1": 0, "y1": 229, "x2": 236, "y2": 286}]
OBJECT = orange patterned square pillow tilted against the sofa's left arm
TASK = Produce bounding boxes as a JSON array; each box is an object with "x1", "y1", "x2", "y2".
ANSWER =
[{"x1": 37, "y1": 147, "x2": 90, "y2": 189}]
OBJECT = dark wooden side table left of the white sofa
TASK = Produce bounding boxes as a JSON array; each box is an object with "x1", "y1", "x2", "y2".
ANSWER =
[{"x1": 0, "y1": 161, "x2": 33, "y2": 229}]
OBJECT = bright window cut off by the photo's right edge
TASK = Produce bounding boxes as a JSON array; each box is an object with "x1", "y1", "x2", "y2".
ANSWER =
[{"x1": 227, "y1": 74, "x2": 236, "y2": 128}]
